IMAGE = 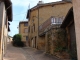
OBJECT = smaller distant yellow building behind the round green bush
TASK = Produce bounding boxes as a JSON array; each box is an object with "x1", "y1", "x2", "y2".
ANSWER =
[{"x1": 19, "y1": 21, "x2": 28, "y2": 44}]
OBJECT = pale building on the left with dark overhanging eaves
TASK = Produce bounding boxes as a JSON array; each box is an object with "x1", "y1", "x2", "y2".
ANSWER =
[{"x1": 0, "y1": 0, "x2": 12, "y2": 60}]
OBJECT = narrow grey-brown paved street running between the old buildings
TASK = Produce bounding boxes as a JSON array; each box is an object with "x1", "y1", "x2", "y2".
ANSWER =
[{"x1": 4, "y1": 43, "x2": 62, "y2": 60}]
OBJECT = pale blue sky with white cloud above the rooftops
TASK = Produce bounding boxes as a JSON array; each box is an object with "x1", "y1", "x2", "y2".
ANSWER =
[{"x1": 8, "y1": 0, "x2": 61, "y2": 37}]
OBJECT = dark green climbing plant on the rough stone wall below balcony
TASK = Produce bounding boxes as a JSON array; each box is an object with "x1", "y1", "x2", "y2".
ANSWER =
[{"x1": 53, "y1": 29, "x2": 67, "y2": 52}]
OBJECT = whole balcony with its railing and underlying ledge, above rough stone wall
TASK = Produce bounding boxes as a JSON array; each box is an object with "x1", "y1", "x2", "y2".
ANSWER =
[{"x1": 39, "y1": 17, "x2": 63, "y2": 36}]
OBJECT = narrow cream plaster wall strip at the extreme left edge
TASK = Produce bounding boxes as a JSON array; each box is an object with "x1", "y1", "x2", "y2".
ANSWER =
[{"x1": 0, "y1": 2, "x2": 5, "y2": 60}]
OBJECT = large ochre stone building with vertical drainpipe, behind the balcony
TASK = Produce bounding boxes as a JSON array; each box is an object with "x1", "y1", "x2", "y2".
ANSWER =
[{"x1": 27, "y1": 1, "x2": 72, "y2": 50}]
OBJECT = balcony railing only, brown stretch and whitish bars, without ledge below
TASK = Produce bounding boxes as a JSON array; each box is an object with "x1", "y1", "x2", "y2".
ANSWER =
[{"x1": 39, "y1": 17, "x2": 63, "y2": 34}]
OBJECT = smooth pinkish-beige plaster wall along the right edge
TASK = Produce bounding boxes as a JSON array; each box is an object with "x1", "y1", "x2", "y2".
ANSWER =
[{"x1": 72, "y1": 0, "x2": 80, "y2": 60}]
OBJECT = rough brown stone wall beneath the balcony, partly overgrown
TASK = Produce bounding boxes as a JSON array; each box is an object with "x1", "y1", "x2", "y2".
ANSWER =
[{"x1": 45, "y1": 28, "x2": 70, "y2": 59}]
